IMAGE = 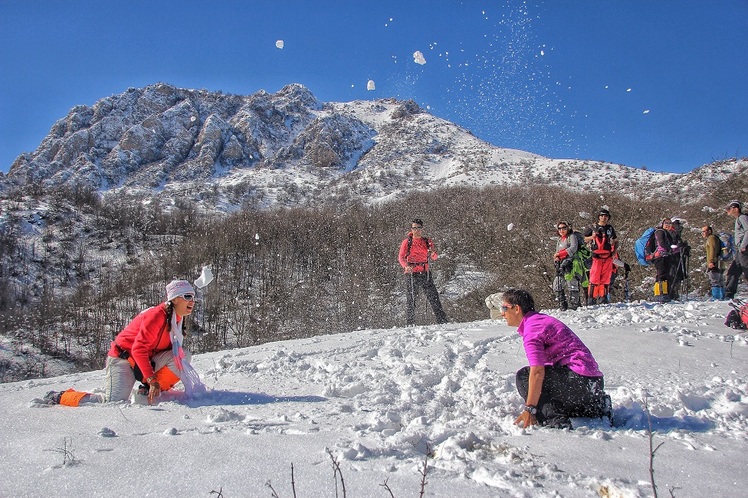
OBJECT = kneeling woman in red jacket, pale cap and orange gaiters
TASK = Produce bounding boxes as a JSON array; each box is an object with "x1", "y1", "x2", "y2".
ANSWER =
[{"x1": 44, "y1": 280, "x2": 195, "y2": 406}]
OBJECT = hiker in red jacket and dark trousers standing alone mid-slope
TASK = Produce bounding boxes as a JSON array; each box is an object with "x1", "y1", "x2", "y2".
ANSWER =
[{"x1": 398, "y1": 218, "x2": 447, "y2": 326}]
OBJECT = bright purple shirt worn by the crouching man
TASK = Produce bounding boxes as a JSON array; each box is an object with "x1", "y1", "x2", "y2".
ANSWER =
[{"x1": 517, "y1": 311, "x2": 603, "y2": 377}]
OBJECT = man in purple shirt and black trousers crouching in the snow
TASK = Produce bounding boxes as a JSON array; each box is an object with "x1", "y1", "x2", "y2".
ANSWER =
[{"x1": 501, "y1": 289, "x2": 611, "y2": 429}]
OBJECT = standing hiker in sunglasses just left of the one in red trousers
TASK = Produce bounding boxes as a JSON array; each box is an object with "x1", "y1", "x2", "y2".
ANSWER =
[{"x1": 553, "y1": 221, "x2": 587, "y2": 310}]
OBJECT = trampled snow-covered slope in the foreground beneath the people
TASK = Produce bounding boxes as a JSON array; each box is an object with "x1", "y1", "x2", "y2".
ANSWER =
[{"x1": 0, "y1": 301, "x2": 748, "y2": 497}]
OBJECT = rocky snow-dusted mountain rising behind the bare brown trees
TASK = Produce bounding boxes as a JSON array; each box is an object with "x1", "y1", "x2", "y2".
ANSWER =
[{"x1": 0, "y1": 83, "x2": 746, "y2": 211}]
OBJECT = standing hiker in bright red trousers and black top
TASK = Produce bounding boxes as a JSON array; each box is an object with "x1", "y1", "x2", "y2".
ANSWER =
[{"x1": 584, "y1": 208, "x2": 618, "y2": 304}]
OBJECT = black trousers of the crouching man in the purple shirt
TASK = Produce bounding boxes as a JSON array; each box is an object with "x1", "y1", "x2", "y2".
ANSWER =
[{"x1": 517, "y1": 366, "x2": 605, "y2": 426}]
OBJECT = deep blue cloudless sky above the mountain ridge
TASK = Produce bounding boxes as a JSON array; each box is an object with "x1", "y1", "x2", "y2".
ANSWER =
[{"x1": 0, "y1": 0, "x2": 748, "y2": 172}]
